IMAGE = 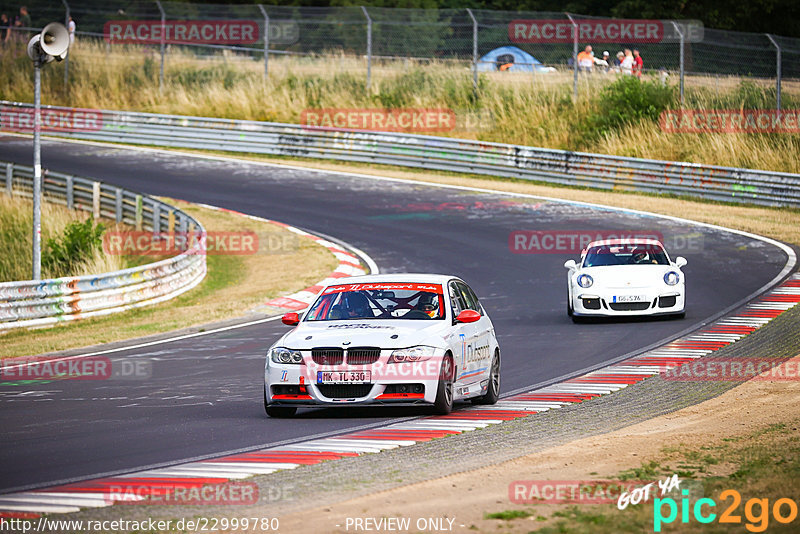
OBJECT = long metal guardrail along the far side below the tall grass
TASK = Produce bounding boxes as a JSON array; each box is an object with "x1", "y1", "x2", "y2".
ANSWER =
[{"x1": 0, "y1": 101, "x2": 800, "y2": 207}]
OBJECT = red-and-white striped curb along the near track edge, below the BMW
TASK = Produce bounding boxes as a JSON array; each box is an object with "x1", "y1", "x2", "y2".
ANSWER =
[{"x1": 0, "y1": 273, "x2": 800, "y2": 518}]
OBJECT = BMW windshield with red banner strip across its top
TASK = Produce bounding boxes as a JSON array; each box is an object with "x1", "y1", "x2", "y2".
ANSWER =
[{"x1": 305, "y1": 283, "x2": 445, "y2": 321}]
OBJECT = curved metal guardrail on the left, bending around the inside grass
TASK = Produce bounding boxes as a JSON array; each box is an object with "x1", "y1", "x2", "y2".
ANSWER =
[{"x1": 0, "y1": 162, "x2": 206, "y2": 331}]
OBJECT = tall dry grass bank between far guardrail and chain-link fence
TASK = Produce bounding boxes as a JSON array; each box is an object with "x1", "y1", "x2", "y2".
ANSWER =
[{"x1": 0, "y1": 41, "x2": 800, "y2": 176}]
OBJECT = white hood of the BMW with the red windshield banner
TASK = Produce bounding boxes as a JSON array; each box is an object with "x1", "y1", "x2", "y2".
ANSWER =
[{"x1": 275, "y1": 319, "x2": 450, "y2": 350}]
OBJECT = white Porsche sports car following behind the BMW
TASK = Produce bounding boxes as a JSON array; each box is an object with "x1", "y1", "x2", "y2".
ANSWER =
[{"x1": 564, "y1": 239, "x2": 686, "y2": 322}]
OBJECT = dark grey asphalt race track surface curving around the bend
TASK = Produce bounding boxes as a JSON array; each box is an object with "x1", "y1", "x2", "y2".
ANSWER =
[{"x1": 0, "y1": 136, "x2": 787, "y2": 492}]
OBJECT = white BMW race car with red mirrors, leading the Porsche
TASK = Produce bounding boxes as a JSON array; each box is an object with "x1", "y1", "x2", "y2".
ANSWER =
[{"x1": 264, "y1": 274, "x2": 500, "y2": 417}]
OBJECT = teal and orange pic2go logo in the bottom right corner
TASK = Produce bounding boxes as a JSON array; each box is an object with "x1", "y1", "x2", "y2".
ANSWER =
[{"x1": 653, "y1": 489, "x2": 797, "y2": 532}]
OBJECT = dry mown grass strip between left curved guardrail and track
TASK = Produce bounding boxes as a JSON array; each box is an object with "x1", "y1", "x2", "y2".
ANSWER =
[{"x1": 0, "y1": 199, "x2": 338, "y2": 358}]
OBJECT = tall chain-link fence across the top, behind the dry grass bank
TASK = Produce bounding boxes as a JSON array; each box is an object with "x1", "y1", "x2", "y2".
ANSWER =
[{"x1": 0, "y1": 0, "x2": 800, "y2": 107}]
